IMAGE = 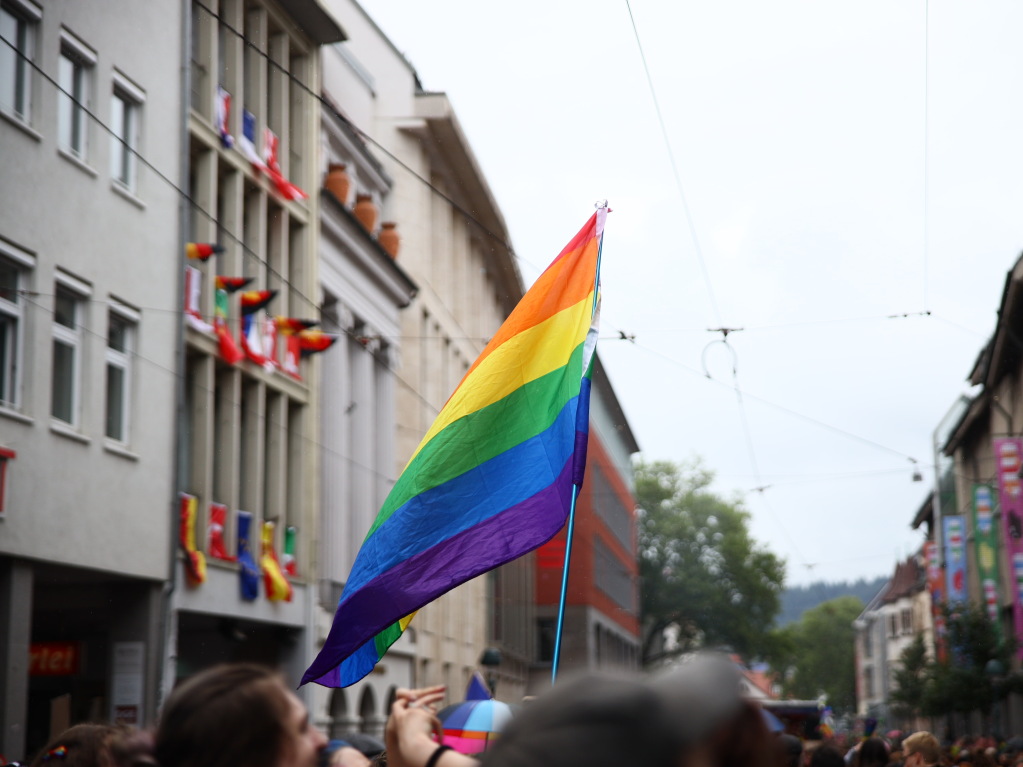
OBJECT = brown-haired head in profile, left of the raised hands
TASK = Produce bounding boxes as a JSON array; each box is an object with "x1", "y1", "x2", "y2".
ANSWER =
[{"x1": 155, "y1": 664, "x2": 327, "y2": 767}]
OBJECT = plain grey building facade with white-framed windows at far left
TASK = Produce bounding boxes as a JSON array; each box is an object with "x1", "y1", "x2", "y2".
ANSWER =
[{"x1": 0, "y1": 0, "x2": 182, "y2": 759}]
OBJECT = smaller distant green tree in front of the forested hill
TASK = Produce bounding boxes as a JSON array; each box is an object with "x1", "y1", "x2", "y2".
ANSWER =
[{"x1": 771, "y1": 596, "x2": 863, "y2": 714}]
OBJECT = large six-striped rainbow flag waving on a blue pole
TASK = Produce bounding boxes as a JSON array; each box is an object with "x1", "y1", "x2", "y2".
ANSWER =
[{"x1": 302, "y1": 209, "x2": 607, "y2": 687}]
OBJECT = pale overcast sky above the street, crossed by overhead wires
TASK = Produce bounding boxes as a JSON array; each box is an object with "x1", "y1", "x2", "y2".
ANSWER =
[{"x1": 353, "y1": 0, "x2": 1023, "y2": 584}]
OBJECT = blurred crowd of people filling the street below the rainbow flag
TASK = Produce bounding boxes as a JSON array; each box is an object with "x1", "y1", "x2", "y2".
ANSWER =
[{"x1": 3, "y1": 656, "x2": 1023, "y2": 767}]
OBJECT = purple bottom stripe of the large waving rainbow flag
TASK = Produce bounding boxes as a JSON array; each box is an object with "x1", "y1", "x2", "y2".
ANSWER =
[{"x1": 302, "y1": 460, "x2": 572, "y2": 684}]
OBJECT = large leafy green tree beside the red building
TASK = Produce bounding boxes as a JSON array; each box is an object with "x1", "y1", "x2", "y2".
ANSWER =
[{"x1": 635, "y1": 461, "x2": 785, "y2": 665}]
